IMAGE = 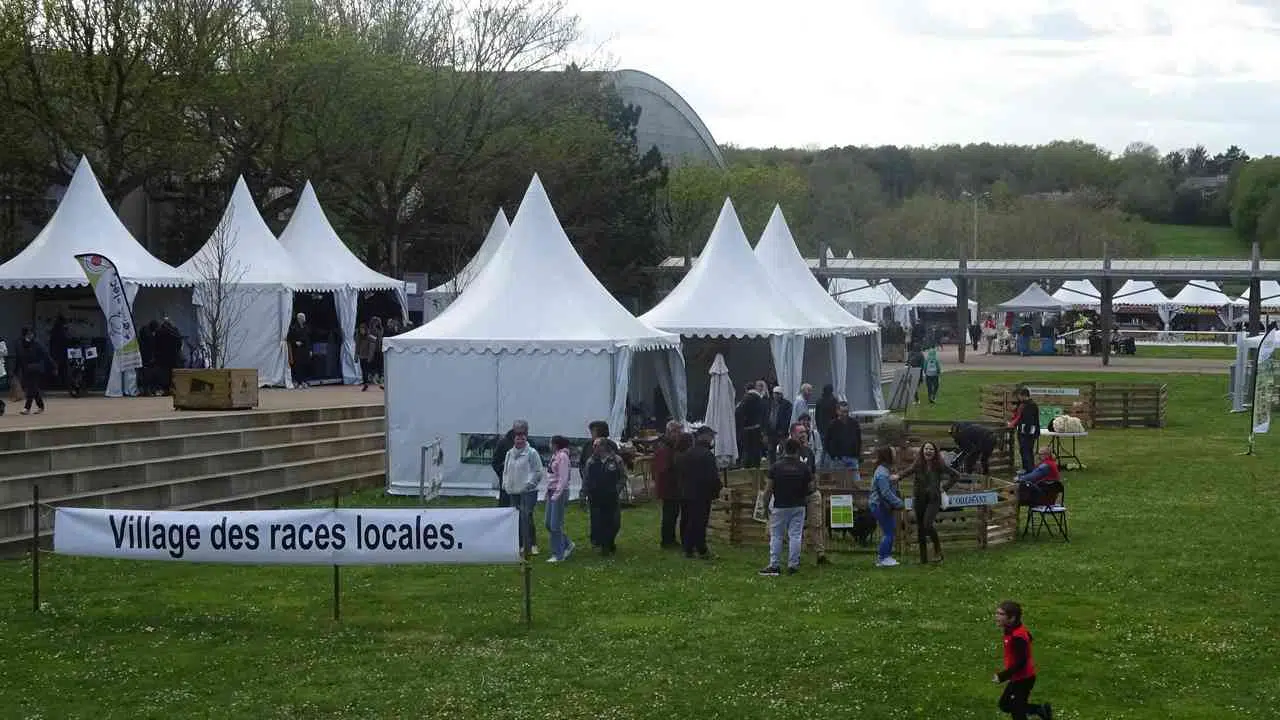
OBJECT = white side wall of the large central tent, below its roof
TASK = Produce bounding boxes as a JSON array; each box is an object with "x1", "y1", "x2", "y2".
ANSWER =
[{"x1": 384, "y1": 351, "x2": 614, "y2": 497}]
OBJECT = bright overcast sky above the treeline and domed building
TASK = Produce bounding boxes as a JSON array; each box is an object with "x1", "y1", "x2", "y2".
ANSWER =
[{"x1": 567, "y1": 0, "x2": 1280, "y2": 155}]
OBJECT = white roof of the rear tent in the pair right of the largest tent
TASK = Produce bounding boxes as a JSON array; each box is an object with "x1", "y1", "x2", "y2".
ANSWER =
[{"x1": 755, "y1": 205, "x2": 879, "y2": 336}]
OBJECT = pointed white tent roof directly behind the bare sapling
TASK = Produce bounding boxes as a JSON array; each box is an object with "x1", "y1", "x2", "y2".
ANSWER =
[{"x1": 178, "y1": 177, "x2": 317, "y2": 290}]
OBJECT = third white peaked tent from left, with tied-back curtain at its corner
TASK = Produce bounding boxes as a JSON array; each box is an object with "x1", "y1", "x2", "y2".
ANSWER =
[{"x1": 280, "y1": 181, "x2": 408, "y2": 384}]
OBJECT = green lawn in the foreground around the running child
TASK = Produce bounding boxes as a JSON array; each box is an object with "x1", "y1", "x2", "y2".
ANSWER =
[{"x1": 0, "y1": 373, "x2": 1280, "y2": 720}]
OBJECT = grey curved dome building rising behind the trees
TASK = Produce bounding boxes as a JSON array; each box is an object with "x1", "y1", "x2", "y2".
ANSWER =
[{"x1": 611, "y1": 70, "x2": 726, "y2": 169}]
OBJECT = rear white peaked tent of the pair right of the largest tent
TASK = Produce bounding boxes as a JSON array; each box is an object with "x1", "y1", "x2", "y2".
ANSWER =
[{"x1": 755, "y1": 206, "x2": 884, "y2": 410}]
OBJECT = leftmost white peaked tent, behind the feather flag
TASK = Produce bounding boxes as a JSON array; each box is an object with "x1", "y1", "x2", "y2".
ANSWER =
[{"x1": 0, "y1": 158, "x2": 192, "y2": 397}]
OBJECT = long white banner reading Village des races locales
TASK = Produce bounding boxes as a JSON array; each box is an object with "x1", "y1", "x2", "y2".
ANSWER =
[{"x1": 54, "y1": 507, "x2": 521, "y2": 565}]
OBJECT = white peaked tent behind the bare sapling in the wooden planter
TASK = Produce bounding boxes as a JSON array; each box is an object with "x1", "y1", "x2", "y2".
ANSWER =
[{"x1": 178, "y1": 178, "x2": 317, "y2": 387}]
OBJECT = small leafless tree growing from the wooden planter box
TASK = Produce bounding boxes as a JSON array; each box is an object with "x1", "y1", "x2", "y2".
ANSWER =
[{"x1": 192, "y1": 206, "x2": 248, "y2": 369}]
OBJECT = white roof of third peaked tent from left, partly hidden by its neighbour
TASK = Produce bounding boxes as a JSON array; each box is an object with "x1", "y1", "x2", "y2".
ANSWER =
[{"x1": 280, "y1": 181, "x2": 404, "y2": 290}]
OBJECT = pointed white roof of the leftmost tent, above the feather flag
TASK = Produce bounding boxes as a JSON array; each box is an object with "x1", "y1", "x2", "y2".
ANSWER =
[{"x1": 0, "y1": 158, "x2": 191, "y2": 288}]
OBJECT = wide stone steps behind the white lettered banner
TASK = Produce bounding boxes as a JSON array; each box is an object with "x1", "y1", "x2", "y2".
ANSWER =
[{"x1": 0, "y1": 405, "x2": 387, "y2": 556}]
